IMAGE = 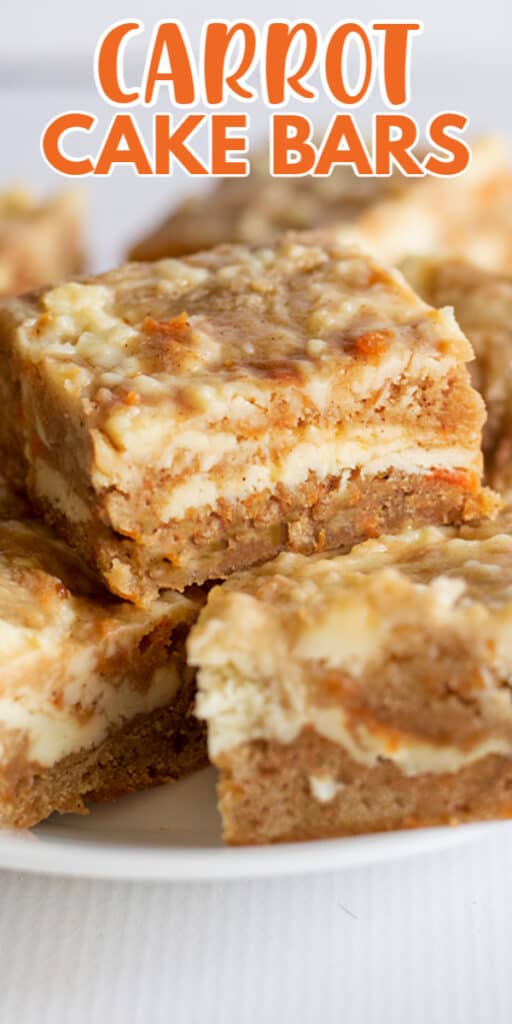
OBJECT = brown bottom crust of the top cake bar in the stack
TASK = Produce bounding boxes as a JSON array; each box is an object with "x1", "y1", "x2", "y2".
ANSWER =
[{"x1": 43, "y1": 470, "x2": 498, "y2": 604}]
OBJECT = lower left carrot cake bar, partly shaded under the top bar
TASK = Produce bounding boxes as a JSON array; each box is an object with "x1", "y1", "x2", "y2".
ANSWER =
[{"x1": 0, "y1": 475, "x2": 207, "y2": 828}]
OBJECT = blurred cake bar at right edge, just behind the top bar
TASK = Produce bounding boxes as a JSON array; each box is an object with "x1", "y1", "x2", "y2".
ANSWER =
[{"x1": 403, "y1": 256, "x2": 512, "y2": 495}]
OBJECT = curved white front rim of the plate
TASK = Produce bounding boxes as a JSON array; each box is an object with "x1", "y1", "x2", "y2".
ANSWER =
[{"x1": 0, "y1": 822, "x2": 495, "y2": 882}]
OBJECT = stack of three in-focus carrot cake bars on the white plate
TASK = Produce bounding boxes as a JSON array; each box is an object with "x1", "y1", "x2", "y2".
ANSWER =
[{"x1": 0, "y1": 146, "x2": 512, "y2": 843}]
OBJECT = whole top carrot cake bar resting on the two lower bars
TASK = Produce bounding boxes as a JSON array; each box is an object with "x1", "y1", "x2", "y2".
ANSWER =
[{"x1": 0, "y1": 236, "x2": 496, "y2": 603}]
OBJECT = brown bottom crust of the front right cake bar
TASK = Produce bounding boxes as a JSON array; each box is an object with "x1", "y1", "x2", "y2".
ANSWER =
[{"x1": 217, "y1": 727, "x2": 512, "y2": 845}]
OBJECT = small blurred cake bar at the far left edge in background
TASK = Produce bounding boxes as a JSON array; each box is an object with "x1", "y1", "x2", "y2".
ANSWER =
[{"x1": 0, "y1": 188, "x2": 83, "y2": 295}]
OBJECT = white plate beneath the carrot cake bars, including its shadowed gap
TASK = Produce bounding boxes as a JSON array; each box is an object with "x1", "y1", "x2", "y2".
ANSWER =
[{"x1": 0, "y1": 769, "x2": 497, "y2": 881}]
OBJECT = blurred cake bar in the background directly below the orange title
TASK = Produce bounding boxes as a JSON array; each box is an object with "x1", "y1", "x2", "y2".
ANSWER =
[{"x1": 129, "y1": 137, "x2": 512, "y2": 271}]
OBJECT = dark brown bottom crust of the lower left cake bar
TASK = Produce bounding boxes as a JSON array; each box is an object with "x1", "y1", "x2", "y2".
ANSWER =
[{"x1": 0, "y1": 684, "x2": 208, "y2": 828}]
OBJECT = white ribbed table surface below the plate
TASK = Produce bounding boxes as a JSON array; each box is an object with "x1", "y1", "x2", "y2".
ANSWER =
[{"x1": 0, "y1": 824, "x2": 512, "y2": 1024}]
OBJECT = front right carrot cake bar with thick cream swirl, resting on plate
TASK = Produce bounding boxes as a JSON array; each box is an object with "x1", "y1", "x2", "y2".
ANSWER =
[{"x1": 188, "y1": 519, "x2": 512, "y2": 844}]
